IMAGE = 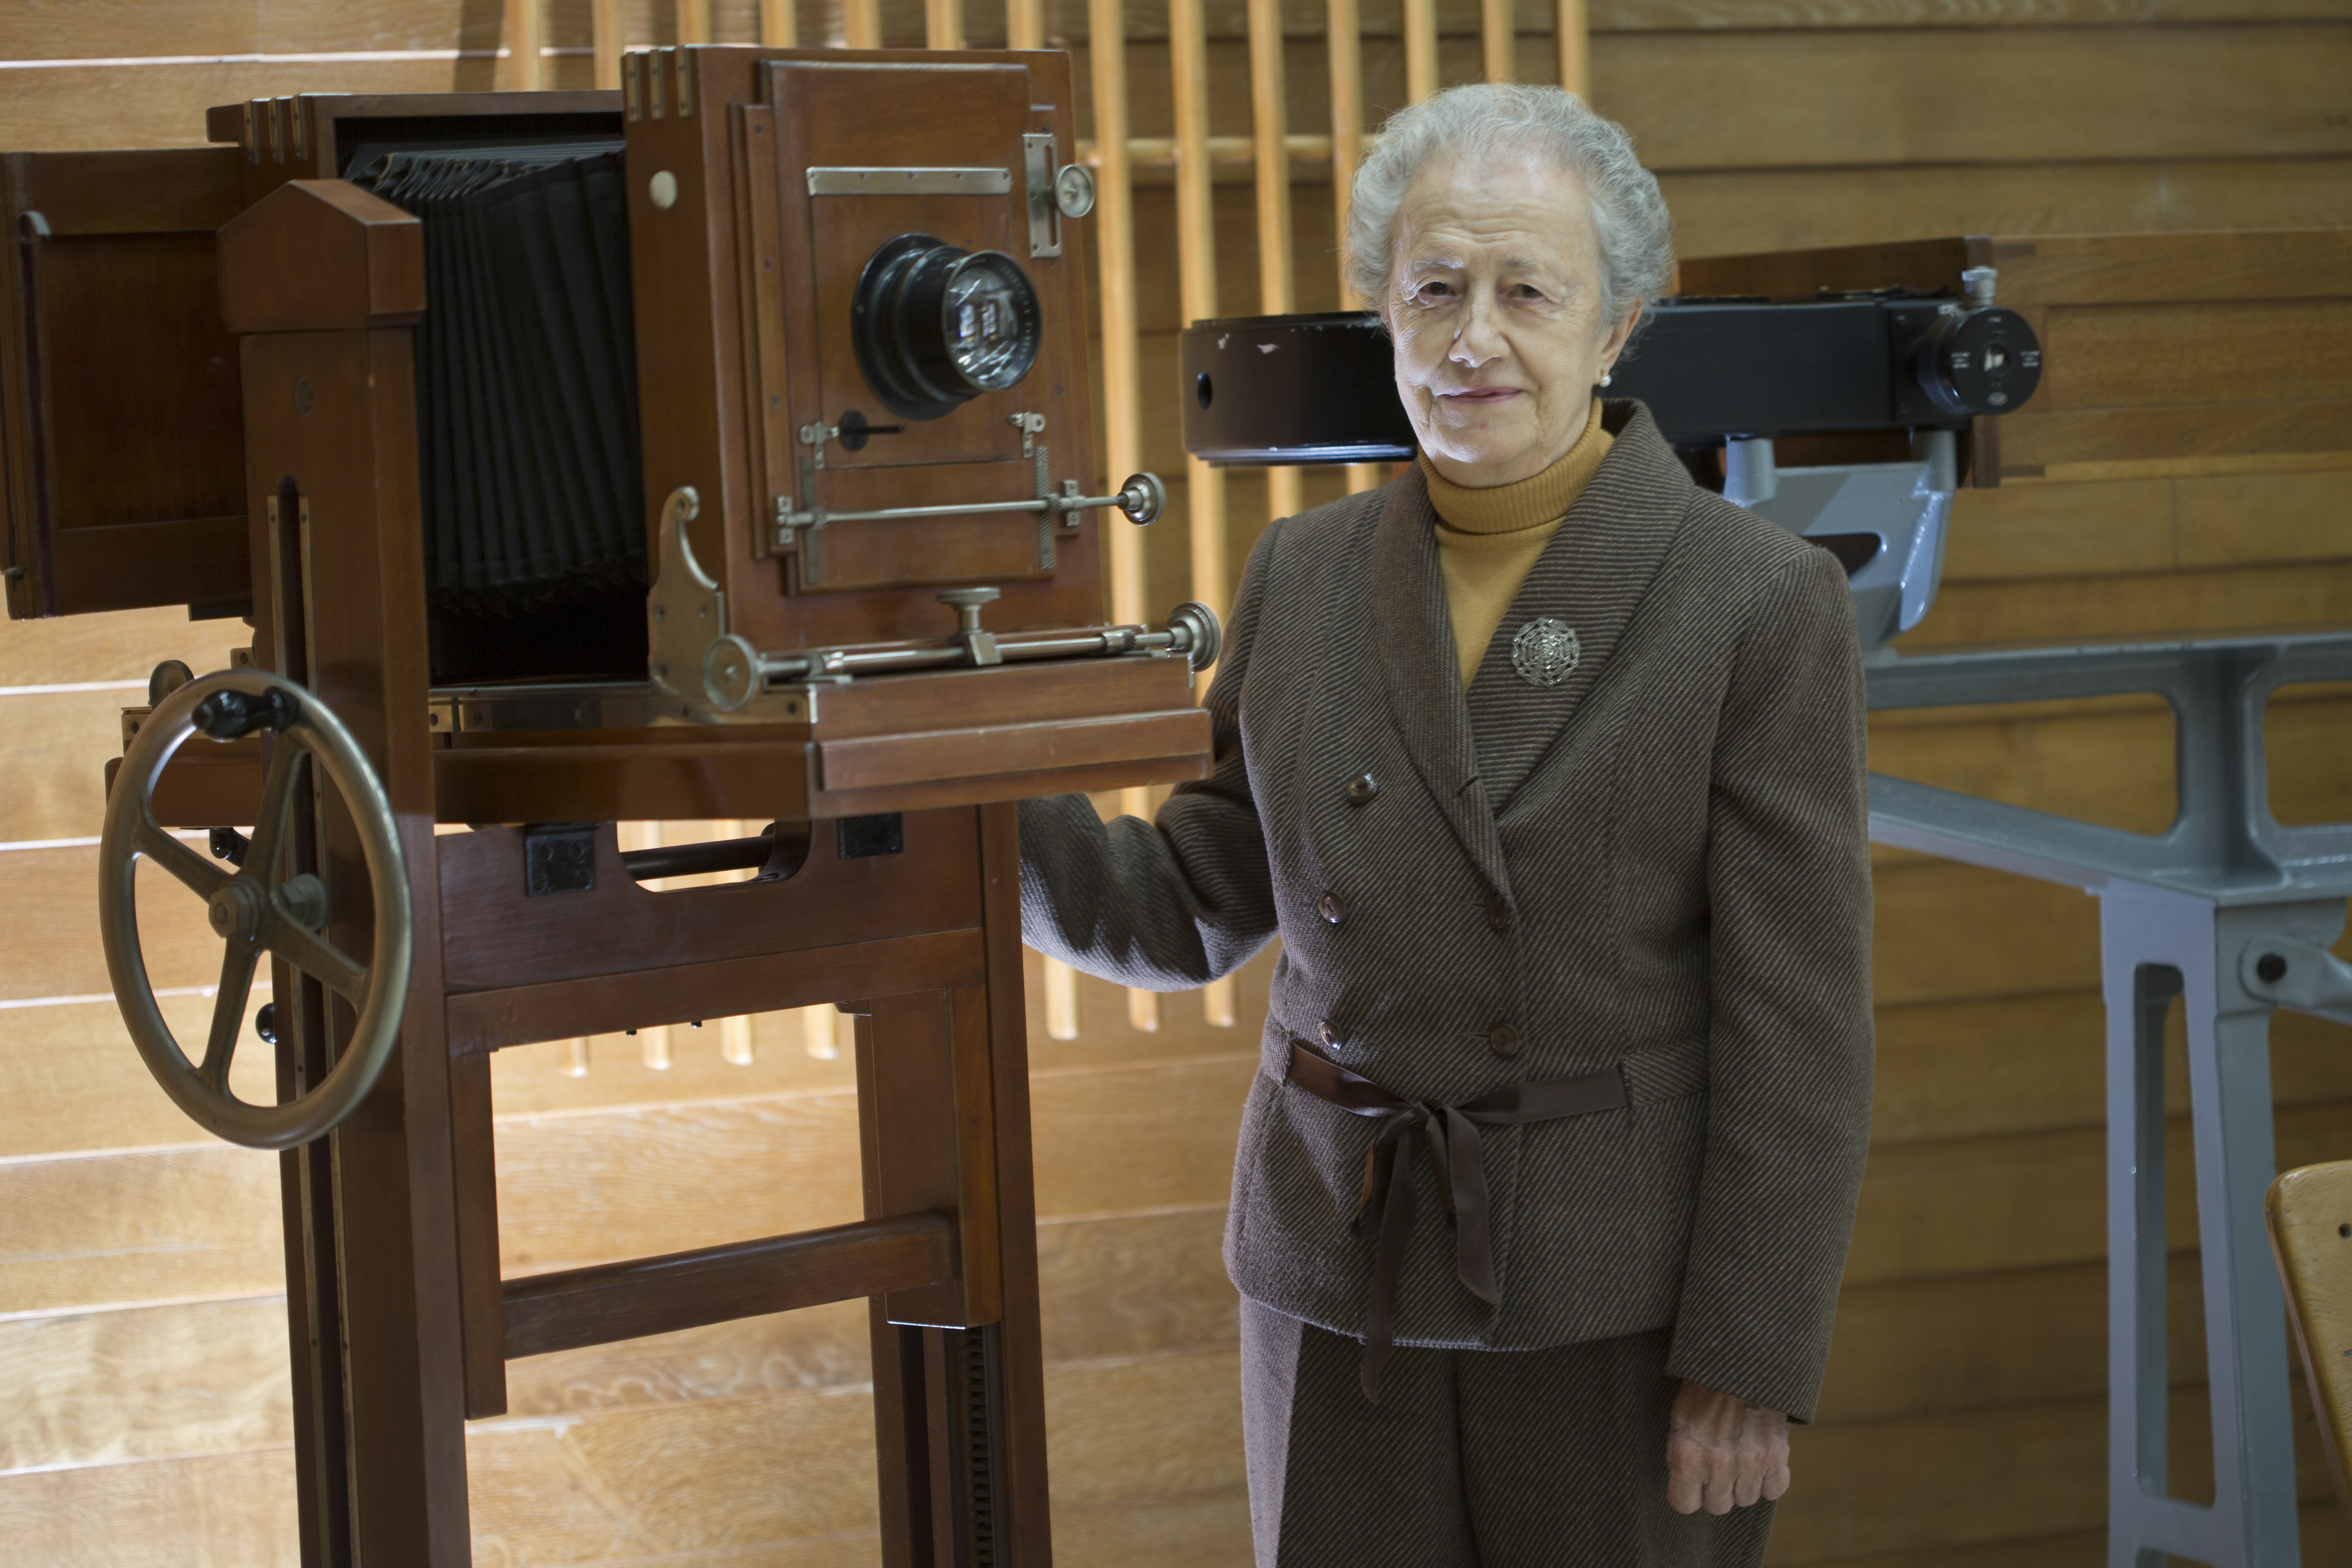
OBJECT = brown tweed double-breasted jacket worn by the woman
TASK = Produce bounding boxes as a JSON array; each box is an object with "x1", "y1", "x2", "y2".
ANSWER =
[{"x1": 1021, "y1": 402, "x2": 1872, "y2": 1420}]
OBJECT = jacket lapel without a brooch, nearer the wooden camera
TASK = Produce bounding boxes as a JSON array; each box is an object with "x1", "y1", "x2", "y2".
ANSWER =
[{"x1": 1367, "y1": 468, "x2": 1510, "y2": 900}]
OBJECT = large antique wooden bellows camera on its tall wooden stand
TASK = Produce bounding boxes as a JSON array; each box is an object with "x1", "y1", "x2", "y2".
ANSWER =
[{"x1": 0, "y1": 47, "x2": 1216, "y2": 1563}]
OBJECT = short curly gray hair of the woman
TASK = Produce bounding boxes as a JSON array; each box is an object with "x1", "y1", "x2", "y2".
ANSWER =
[{"x1": 1348, "y1": 82, "x2": 1675, "y2": 322}]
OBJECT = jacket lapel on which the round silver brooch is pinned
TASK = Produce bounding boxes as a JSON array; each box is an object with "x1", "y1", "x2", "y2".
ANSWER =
[{"x1": 1458, "y1": 400, "x2": 1691, "y2": 816}]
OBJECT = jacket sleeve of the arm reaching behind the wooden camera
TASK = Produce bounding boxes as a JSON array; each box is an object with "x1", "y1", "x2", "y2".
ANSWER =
[{"x1": 1021, "y1": 522, "x2": 1282, "y2": 990}]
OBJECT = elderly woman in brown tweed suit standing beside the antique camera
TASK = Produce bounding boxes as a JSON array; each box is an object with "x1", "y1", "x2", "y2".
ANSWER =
[{"x1": 1021, "y1": 87, "x2": 1872, "y2": 1568}]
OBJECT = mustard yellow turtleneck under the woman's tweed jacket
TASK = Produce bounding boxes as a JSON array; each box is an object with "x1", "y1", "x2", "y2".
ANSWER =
[{"x1": 1421, "y1": 397, "x2": 1609, "y2": 691}]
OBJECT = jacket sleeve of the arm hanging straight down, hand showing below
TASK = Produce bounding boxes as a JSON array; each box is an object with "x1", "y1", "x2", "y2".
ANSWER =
[{"x1": 1667, "y1": 550, "x2": 1872, "y2": 1420}]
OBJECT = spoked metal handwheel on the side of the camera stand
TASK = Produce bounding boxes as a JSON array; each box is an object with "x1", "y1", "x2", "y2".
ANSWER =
[{"x1": 99, "y1": 670, "x2": 409, "y2": 1150}]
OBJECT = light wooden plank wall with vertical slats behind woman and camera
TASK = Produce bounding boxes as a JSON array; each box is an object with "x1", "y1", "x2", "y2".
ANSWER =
[{"x1": 0, "y1": 0, "x2": 2352, "y2": 1568}]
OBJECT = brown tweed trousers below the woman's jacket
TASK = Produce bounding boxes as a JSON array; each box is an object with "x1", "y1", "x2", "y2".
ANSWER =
[{"x1": 1242, "y1": 1298, "x2": 1773, "y2": 1568}]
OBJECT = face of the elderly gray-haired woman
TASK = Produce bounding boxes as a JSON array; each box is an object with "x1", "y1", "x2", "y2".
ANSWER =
[{"x1": 1381, "y1": 158, "x2": 1632, "y2": 487}]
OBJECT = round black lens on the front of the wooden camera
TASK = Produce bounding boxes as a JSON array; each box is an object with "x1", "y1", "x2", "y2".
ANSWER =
[{"x1": 849, "y1": 235, "x2": 1040, "y2": 418}]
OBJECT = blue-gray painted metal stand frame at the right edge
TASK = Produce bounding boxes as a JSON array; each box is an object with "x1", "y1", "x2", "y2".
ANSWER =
[{"x1": 1870, "y1": 635, "x2": 2352, "y2": 1568}]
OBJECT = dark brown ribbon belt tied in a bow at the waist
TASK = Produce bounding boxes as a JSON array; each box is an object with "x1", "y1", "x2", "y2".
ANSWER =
[{"x1": 1289, "y1": 1039, "x2": 1630, "y2": 1403}]
